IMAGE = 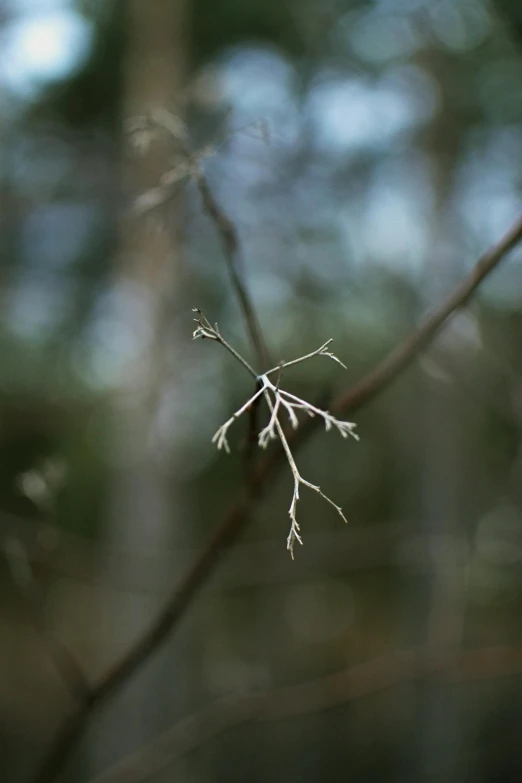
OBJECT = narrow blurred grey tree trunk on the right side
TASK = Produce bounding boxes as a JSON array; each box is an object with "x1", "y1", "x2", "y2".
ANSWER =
[{"x1": 417, "y1": 48, "x2": 466, "y2": 783}]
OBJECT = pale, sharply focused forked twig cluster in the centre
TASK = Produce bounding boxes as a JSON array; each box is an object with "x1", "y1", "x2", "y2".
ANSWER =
[{"x1": 193, "y1": 309, "x2": 359, "y2": 558}]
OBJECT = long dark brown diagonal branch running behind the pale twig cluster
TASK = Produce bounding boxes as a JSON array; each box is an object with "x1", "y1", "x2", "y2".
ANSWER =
[{"x1": 30, "y1": 217, "x2": 522, "y2": 783}]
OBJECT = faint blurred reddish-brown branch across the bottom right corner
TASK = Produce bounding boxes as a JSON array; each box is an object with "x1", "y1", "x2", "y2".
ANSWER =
[{"x1": 90, "y1": 646, "x2": 522, "y2": 783}]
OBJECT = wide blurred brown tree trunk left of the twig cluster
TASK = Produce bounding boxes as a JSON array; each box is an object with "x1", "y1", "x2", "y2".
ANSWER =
[{"x1": 85, "y1": 0, "x2": 187, "y2": 771}]
